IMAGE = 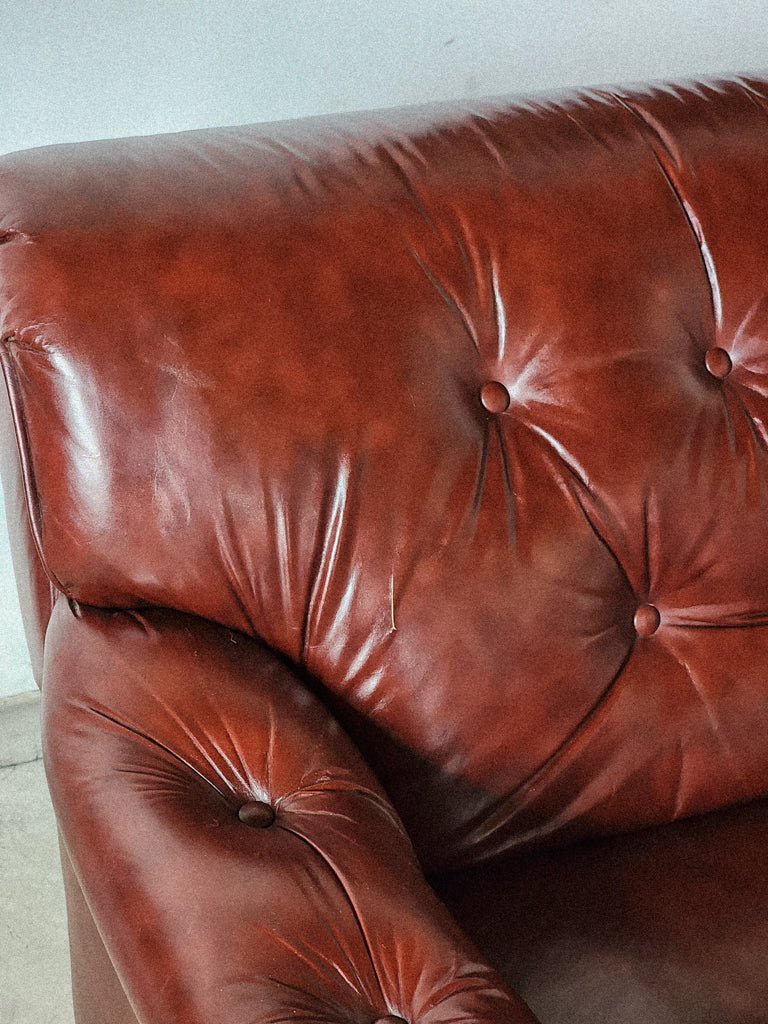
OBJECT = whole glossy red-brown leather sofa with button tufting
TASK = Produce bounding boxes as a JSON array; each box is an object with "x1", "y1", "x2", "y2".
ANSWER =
[{"x1": 0, "y1": 78, "x2": 768, "y2": 1024}]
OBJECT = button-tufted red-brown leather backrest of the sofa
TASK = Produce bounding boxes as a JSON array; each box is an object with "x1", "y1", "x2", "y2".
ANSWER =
[{"x1": 0, "y1": 80, "x2": 768, "y2": 866}]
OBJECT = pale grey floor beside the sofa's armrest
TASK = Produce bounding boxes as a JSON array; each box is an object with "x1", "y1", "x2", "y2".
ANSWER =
[{"x1": 0, "y1": 761, "x2": 74, "y2": 1024}]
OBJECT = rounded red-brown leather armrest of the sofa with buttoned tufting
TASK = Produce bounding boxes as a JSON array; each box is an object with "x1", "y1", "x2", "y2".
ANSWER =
[{"x1": 43, "y1": 600, "x2": 535, "y2": 1024}]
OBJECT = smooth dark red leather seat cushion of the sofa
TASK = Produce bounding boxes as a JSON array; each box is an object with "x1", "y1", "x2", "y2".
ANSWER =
[{"x1": 437, "y1": 802, "x2": 768, "y2": 1024}]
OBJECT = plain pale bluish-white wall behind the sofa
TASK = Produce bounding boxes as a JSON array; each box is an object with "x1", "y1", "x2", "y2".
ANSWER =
[{"x1": 0, "y1": 0, "x2": 768, "y2": 696}]
